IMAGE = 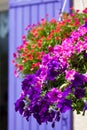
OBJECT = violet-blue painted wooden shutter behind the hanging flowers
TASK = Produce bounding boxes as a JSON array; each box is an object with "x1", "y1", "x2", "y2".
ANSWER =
[{"x1": 8, "y1": 0, "x2": 72, "y2": 130}]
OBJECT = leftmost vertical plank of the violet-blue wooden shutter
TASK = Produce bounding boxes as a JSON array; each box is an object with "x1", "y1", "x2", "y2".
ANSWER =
[{"x1": 8, "y1": 9, "x2": 16, "y2": 130}]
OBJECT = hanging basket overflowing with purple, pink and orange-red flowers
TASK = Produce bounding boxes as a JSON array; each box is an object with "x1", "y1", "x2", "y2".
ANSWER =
[{"x1": 13, "y1": 8, "x2": 87, "y2": 126}]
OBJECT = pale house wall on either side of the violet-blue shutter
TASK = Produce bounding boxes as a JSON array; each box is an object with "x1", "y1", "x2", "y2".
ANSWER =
[{"x1": 0, "y1": 0, "x2": 87, "y2": 130}]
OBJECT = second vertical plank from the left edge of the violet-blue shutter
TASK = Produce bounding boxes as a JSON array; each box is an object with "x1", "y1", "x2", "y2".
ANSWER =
[{"x1": 14, "y1": 8, "x2": 22, "y2": 130}]
